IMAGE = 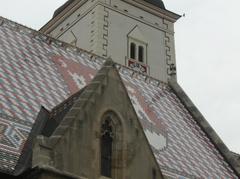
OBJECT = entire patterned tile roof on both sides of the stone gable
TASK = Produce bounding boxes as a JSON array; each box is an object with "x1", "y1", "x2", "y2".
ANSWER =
[{"x1": 0, "y1": 18, "x2": 238, "y2": 178}]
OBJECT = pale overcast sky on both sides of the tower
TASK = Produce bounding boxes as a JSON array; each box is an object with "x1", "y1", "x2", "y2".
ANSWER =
[{"x1": 0, "y1": 0, "x2": 240, "y2": 153}]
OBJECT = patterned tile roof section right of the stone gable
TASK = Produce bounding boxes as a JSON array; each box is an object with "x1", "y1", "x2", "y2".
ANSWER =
[{"x1": 119, "y1": 67, "x2": 237, "y2": 178}]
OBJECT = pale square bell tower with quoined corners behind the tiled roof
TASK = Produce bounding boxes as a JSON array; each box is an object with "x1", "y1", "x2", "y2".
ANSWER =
[{"x1": 40, "y1": 0, "x2": 180, "y2": 82}]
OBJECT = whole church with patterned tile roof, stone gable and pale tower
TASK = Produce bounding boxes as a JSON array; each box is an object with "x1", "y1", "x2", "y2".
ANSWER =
[{"x1": 0, "y1": 0, "x2": 240, "y2": 179}]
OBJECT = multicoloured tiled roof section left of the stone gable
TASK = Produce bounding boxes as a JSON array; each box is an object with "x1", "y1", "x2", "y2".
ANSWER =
[{"x1": 0, "y1": 17, "x2": 104, "y2": 172}]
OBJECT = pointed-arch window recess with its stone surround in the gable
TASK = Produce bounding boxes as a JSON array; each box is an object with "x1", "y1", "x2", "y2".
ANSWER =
[{"x1": 99, "y1": 111, "x2": 124, "y2": 179}]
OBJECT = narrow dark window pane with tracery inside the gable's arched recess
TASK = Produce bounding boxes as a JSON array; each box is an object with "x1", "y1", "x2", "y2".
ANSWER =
[{"x1": 101, "y1": 117, "x2": 114, "y2": 178}]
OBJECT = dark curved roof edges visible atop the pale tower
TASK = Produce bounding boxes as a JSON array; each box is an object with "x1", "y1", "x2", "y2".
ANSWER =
[{"x1": 53, "y1": 0, "x2": 165, "y2": 17}]
